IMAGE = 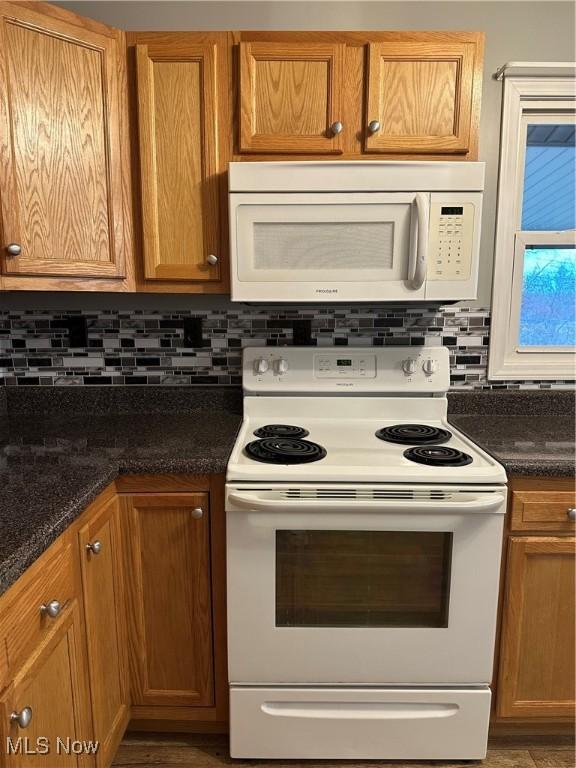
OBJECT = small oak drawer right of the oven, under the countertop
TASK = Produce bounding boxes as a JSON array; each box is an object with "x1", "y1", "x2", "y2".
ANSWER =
[{"x1": 511, "y1": 489, "x2": 576, "y2": 532}]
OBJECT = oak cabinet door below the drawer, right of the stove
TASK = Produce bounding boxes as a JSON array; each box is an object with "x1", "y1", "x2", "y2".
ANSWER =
[{"x1": 497, "y1": 536, "x2": 576, "y2": 718}]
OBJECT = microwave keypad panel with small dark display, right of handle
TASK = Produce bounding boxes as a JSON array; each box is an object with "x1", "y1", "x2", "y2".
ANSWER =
[{"x1": 428, "y1": 202, "x2": 475, "y2": 280}]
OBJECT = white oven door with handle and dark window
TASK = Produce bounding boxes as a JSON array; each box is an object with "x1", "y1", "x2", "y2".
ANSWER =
[{"x1": 226, "y1": 484, "x2": 506, "y2": 685}]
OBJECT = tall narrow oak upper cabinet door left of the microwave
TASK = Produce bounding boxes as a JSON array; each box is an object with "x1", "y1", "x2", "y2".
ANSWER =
[{"x1": 136, "y1": 36, "x2": 227, "y2": 282}]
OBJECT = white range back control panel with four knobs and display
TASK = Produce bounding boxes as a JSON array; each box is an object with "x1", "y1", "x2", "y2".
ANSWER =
[{"x1": 242, "y1": 347, "x2": 450, "y2": 395}]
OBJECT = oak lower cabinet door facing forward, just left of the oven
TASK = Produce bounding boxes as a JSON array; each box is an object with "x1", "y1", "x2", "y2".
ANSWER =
[{"x1": 126, "y1": 493, "x2": 214, "y2": 706}]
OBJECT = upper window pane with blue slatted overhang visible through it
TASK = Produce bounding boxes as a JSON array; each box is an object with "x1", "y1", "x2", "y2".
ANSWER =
[{"x1": 521, "y1": 123, "x2": 576, "y2": 231}]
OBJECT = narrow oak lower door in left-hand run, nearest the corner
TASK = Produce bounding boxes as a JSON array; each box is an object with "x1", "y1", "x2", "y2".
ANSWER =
[{"x1": 79, "y1": 498, "x2": 129, "y2": 766}]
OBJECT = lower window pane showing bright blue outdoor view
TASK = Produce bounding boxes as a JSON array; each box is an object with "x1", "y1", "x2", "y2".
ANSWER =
[{"x1": 519, "y1": 246, "x2": 576, "y2": 347}]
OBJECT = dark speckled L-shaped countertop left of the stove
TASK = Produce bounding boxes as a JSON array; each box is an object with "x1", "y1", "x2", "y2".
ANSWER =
[{"x1": 0, "y1": 389, "x2": 242, "y2": 594}]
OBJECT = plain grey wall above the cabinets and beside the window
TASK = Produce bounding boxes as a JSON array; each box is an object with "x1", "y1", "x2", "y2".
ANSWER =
[{"x1": 58, "y1": 0, "x2": 576, "y2": 306}]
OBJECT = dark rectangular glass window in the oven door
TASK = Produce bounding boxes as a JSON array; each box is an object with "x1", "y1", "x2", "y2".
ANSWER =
[{"x1": 276, "y1": 530, "x2": 452, "y2": 627}]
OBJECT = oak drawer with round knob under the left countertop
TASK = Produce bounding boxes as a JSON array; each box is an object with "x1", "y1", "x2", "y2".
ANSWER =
[{"x1": 0, "y1": 543, "x2": 75, "y2": 674}]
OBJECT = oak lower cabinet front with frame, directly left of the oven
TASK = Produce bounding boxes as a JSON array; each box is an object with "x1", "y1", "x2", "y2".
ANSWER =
[{"x1": 117, "y1": 475, "x2": 228, "y2": 732}]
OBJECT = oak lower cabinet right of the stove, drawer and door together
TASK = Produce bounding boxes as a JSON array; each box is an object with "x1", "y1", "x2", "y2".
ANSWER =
[{"x1": 496, "y1": 478, "x2": 576, "y2": 723}]
